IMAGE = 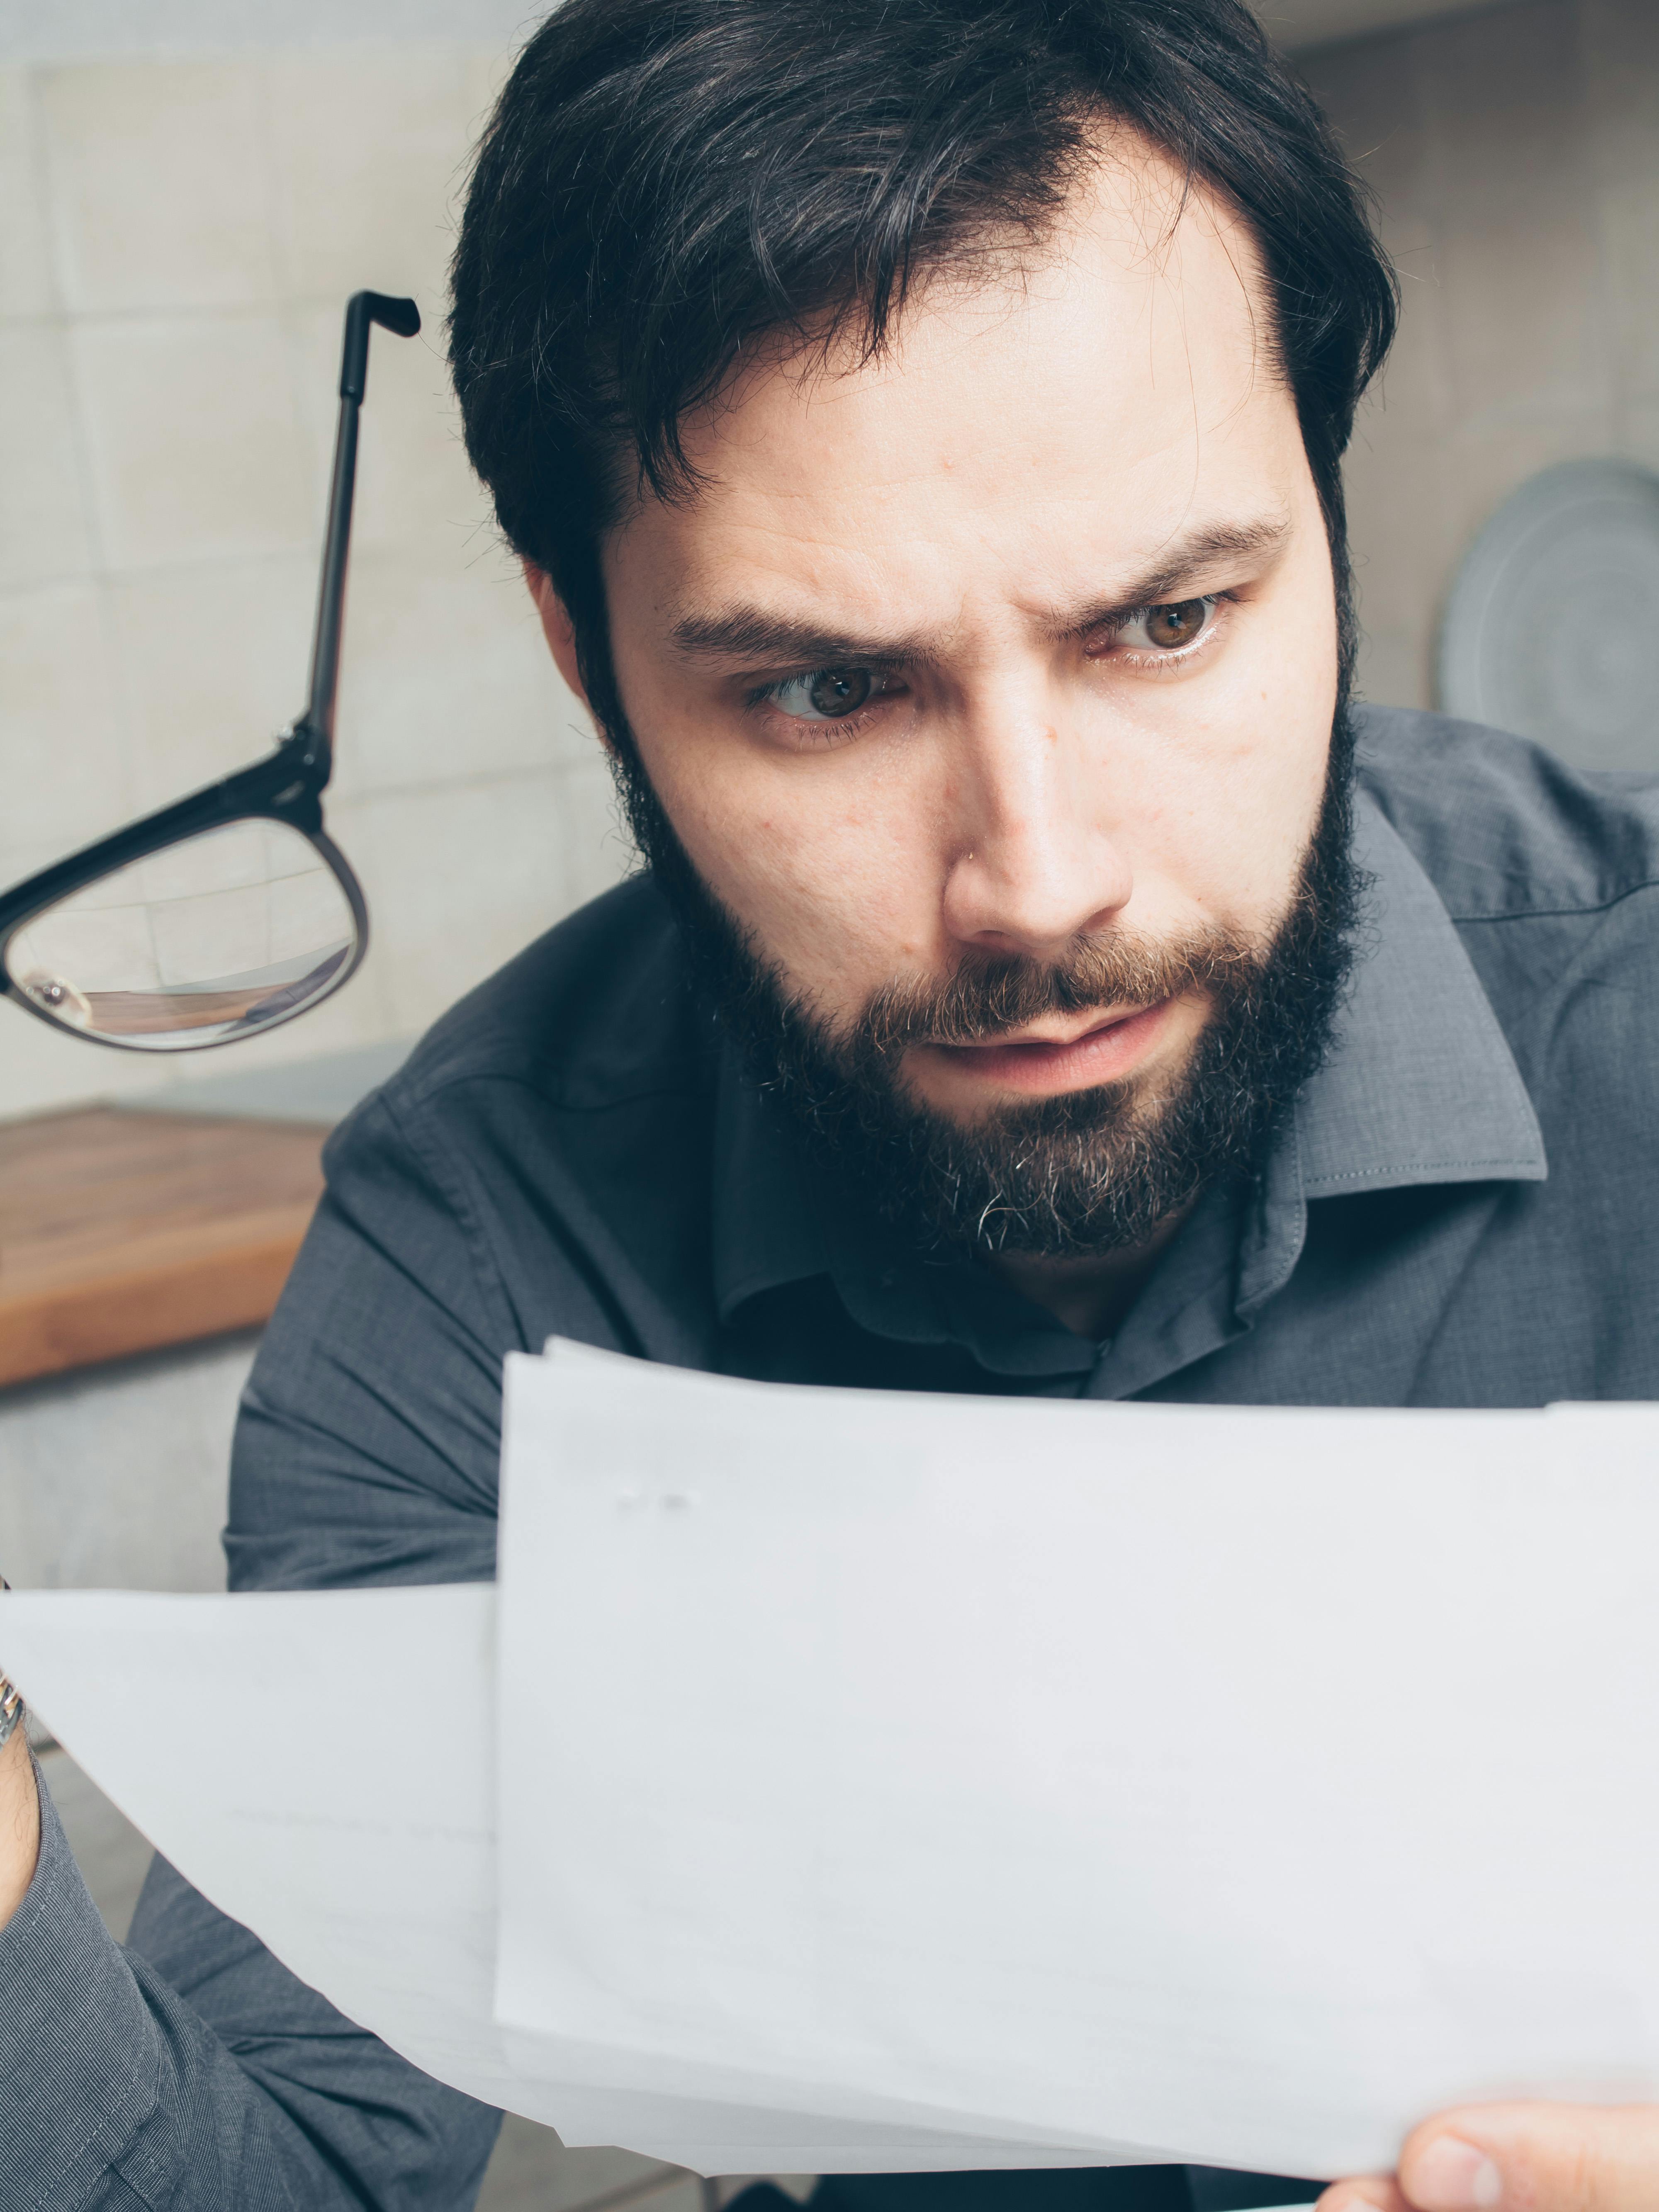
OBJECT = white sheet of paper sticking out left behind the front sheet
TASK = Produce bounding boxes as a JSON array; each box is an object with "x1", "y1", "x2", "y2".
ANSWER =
[{"x1": 0, "y1": 1586, "x2": 1092, "y2": 2174}]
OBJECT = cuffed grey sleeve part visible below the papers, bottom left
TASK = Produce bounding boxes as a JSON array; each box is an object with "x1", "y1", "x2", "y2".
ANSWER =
[{"x1": 0, "y1": 1745, "x2": 500, "y2": 2212}]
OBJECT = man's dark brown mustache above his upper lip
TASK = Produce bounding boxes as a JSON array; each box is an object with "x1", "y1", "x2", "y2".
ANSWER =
[{"x1": 847, "y1": 929, "x2": 1265, "y2": 1060}]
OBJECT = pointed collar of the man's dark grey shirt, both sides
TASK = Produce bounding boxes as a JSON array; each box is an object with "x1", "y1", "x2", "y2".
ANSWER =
[{"x1": 715, "y1": 788, "x2": 1548, "y2": 1345}]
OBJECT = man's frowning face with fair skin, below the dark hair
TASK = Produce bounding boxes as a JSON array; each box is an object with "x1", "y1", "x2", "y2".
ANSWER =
[{"x1": 533, "y1": 157, "x2": 1338, "y2": 1256}]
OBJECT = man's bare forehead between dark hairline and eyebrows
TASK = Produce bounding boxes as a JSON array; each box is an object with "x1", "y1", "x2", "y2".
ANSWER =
[{"x1": 606, "y1": 146, "x2": 1305, "y2": 617}]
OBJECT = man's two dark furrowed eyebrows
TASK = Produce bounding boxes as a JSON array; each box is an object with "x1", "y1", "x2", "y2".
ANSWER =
[{"x1": 668, "y1": 515, "x2": 1292, "y2": 668}]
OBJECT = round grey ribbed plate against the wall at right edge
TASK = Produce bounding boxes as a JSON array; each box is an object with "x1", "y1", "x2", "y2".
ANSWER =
[{"x1": 1440, "y1": 460, "x2": 1659, "y2": 770}]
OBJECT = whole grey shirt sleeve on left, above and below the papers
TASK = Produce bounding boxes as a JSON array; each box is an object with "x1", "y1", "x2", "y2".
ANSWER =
[{"x1": 0, "y1": 1099, "x2": 526, "y2": 2212}]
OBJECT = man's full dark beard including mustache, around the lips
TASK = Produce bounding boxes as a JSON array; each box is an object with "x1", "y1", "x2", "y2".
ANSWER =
[{"x1": 608, "y1": 701, "x2": 1365, "y2": 1259}]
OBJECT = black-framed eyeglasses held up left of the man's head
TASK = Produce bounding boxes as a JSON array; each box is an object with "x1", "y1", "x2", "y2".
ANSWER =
[{"x1": 0, "y1": 292, "x2": 420, "y2": 1053}]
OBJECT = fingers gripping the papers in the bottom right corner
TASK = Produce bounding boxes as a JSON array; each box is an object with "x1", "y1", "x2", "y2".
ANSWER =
[{"x1": 1318, "y1": 2104, "x2": 1659, "y2": 2212}]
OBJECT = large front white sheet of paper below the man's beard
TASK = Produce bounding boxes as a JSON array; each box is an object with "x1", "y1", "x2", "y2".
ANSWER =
[{"x1": 496, "y1": 1347, "x2": 1659, "y2": 2174}]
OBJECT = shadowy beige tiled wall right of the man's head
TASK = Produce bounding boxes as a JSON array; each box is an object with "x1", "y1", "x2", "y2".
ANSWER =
[{"x1": 1303, "y1": 0, "x2": 1659, "y2": 706}]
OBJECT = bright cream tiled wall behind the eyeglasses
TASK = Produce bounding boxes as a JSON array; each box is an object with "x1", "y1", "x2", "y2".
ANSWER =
[{"x1": 0, "y1": 42, "x2": 626, "y2": 1117}]
